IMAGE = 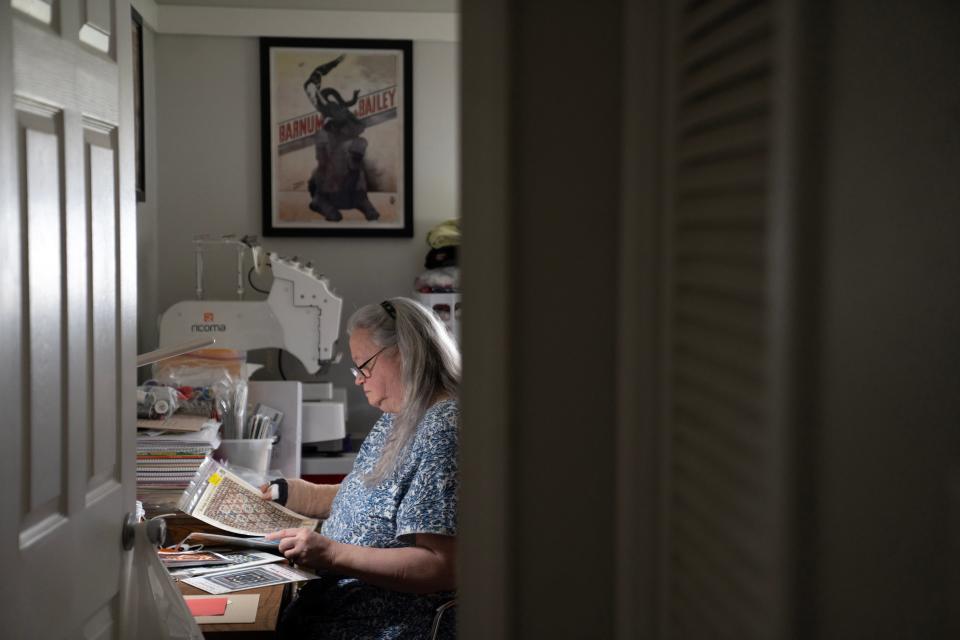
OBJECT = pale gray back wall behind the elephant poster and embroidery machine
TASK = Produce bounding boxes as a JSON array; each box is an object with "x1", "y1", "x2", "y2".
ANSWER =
[{"x1": 152, "y1": 34, "x2": 459, "y2": 433}]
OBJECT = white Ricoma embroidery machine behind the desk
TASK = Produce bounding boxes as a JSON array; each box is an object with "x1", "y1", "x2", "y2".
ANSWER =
[{"x1": 159, "y1": 235, "x2": 346, "y2": 477}]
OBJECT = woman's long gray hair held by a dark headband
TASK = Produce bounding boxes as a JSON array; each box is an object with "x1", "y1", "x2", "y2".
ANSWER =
[{"x1": 347, "y1": 298, "x2": 460, "y2": 486}]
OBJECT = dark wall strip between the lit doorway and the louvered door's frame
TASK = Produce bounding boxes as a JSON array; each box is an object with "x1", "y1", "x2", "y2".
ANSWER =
[{"x1": 457, "y1": 0, "x2": 634, "y2": 638}]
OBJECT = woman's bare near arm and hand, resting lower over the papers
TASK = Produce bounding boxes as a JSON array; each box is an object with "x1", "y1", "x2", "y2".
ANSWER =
[{"x1": 267, "y1": 529, "x2": 457, "y2": 593}]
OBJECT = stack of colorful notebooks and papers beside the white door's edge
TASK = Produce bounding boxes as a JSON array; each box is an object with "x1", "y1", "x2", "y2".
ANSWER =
[{"x1": 137, "y1": 421, "x2": 220, "y2": 494}]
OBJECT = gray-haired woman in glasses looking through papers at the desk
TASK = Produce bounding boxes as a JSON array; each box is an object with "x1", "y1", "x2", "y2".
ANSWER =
[{"x1": 264, "y1": 298, "x2": 460, "y2": 639}]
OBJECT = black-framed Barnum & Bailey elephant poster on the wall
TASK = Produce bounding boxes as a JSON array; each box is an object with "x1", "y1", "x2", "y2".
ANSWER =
[{"x1": 260, "y1": 38, "x2": 413, "y2": 237}]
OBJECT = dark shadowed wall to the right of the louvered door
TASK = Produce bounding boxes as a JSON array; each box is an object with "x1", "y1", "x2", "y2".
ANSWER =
[{"x1": 804, "y1": 0, "x2": 960, "y2": 638}]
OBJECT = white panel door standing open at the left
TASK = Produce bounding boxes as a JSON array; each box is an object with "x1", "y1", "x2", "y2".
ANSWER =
[{"x1": 0, "y1": 0, "x2": 136, "y2": 639}]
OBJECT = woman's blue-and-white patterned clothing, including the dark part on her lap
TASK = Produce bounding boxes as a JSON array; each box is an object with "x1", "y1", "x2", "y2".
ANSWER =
[{"x1": 279, "y1": 400, "x2": 460, "y2": 640}]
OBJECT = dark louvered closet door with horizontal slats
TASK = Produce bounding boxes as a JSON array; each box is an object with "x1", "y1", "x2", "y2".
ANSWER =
[{"x1": 663, "y1": 0, "x2": 786, "y2": 640}]
